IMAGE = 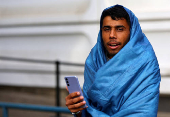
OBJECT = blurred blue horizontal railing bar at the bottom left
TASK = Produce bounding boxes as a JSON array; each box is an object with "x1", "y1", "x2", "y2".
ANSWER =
[{"x1": 0, "y1": 102, "x2": 70, "y2": 113}]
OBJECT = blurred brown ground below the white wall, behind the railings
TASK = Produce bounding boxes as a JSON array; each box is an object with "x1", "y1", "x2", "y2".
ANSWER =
[{"x1": 0, "y1": 86, "x2": 170, "y2": 117}]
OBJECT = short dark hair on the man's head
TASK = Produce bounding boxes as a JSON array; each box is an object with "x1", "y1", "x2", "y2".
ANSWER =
[{"x1": 100, "y1": 5, "x2": 130, "y2": 27}]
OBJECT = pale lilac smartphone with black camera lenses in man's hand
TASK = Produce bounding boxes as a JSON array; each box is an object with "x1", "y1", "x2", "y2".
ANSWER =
[{"x1": 64, "y1": 76, "x2": 86, "y2": 108}]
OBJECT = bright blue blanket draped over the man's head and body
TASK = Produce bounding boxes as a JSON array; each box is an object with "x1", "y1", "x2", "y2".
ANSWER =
[{"x1": 82, "y1": 6, "x2": 161, "y2": 117}]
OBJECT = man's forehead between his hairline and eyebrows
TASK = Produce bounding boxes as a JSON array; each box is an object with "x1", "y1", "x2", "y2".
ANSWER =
[{"x1": 102, "y1": 16, "x2": 129, "y2": 27}]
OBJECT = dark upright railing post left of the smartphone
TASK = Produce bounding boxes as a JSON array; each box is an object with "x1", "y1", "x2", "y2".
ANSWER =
[{"x1": 55, "y1": 61, "x2": 60, "y2": 117}]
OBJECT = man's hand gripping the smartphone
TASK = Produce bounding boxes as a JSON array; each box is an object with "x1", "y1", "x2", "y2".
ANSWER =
[{"x1": 65, "y1": 87, "x2": 87, "y2": 115}]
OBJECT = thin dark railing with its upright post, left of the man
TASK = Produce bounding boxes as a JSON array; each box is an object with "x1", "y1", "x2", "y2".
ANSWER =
[{"x1": 0, "y1": 56, "x2": 84, "y2": 116}]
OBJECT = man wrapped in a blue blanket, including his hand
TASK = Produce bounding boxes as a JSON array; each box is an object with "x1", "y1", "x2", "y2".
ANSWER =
[{"x1": 66, "y1": 5, "x2": 161, "y2": 117}]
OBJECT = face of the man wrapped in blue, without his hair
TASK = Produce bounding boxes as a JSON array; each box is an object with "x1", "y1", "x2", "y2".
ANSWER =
[{"x1": 102, "y1": 16, "x2": 130, "y2": 59}]
